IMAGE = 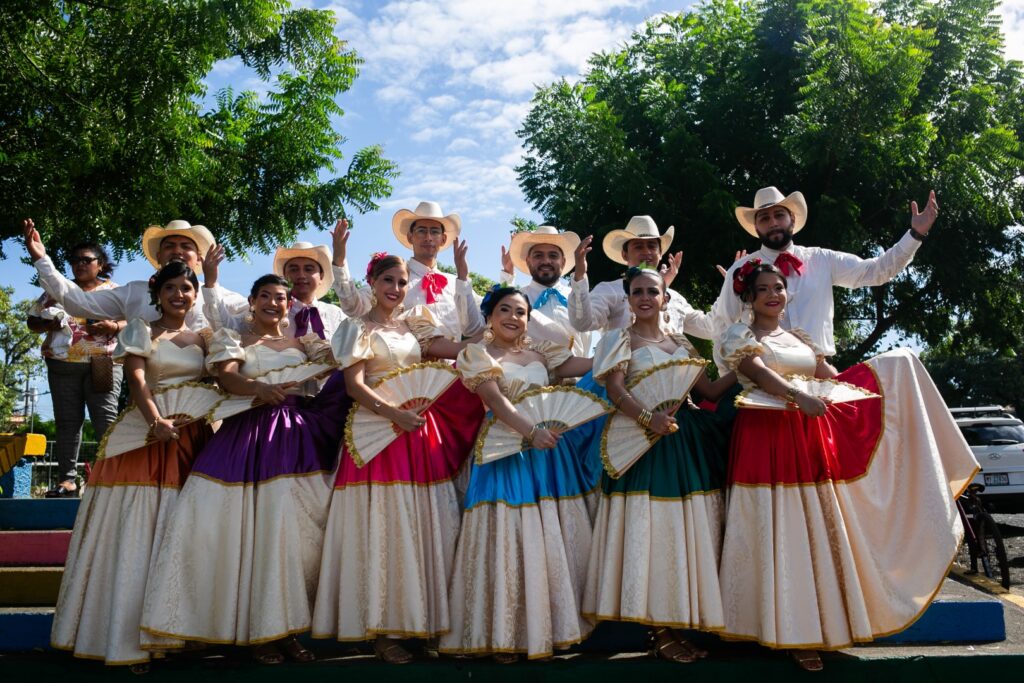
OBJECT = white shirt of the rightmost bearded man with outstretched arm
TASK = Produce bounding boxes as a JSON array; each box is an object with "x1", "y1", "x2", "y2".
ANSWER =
[{"x1": 708, "y1": 231, "x2": 921, "y2": 359}]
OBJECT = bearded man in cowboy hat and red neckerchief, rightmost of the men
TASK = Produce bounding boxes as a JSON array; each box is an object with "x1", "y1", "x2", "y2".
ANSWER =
[{"x1": 706, "y1": 187, "x2": 939, "y2": 356}]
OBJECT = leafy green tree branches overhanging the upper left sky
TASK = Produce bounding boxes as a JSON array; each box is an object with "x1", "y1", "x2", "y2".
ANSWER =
[{"x1": 0, "y1": 0, "x2": 396, "y2": 264}]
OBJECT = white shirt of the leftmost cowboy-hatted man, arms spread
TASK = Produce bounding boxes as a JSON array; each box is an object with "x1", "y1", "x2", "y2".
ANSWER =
[{"x1": 35, "y1": 256, "x2": 249, "y2": 332}]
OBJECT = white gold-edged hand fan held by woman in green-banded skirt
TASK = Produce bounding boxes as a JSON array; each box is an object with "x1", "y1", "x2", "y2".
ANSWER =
[{"x1": 601, "y1": 358, "x2": 708, "y2": 479}]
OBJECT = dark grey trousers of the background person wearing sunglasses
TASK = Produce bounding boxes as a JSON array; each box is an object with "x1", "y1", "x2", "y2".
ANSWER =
[{"x1": 46, "y1": 358, "x2": 122, "y2": 481}]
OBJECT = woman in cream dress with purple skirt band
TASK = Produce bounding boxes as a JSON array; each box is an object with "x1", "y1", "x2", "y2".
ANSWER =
[{"x1": 142, "y1": 274, "x2": 344, "y2": 665}]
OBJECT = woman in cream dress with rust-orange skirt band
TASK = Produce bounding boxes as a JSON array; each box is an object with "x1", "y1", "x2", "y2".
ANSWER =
[{"x1": 50, "y1": 261, "x2": 210, "y2": 673}]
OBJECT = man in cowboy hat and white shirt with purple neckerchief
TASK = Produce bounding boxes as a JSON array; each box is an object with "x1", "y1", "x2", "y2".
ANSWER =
[{"x1": 206, "y1": 242, "x2": 345, "y2": 340}]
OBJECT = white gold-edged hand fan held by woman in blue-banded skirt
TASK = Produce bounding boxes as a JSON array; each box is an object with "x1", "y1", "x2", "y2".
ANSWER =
[{"x1": 473, "y1": 386, "x2": 611, "y2": 465}]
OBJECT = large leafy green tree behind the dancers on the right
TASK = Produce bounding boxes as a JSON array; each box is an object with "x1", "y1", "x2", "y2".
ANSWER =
[{"x1": 517, "y1": 0, "x2": 1024, "y2": 365}]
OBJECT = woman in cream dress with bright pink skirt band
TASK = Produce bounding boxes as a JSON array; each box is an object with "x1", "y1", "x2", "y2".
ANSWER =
[{"x1": 313, "y1": 254, "x2": 483, "y2": 664}]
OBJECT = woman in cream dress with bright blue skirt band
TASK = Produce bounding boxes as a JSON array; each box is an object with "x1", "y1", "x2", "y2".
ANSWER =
[{"x1": 440, "y1": 287, "x2": 599, "y2": 664}]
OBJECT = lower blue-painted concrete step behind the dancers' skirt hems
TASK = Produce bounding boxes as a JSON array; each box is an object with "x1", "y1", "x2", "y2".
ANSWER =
[{"x1": 0, "y1": 581, "x2": 1007, "y2": 652}]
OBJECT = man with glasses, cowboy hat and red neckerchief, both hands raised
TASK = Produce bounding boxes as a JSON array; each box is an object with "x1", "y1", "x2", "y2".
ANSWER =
[{"x1": 332, "y1": 202, "x2": 483, "y2": 342}]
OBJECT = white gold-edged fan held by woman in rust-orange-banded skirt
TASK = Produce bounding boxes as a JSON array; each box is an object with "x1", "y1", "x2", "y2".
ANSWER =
[{"x1": 96, "y1": 382, "x2": 224, "y2": 460}]
